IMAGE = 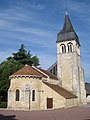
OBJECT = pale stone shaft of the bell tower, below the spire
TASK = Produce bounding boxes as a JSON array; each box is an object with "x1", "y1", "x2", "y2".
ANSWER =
[{"x1": 57, "y1": 40, "x2": 86, "y2": 104}]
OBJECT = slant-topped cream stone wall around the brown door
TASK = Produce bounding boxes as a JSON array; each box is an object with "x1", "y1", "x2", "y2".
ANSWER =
[{"x1": 41, "y1": 83, "x2": 66, "y2": 109}]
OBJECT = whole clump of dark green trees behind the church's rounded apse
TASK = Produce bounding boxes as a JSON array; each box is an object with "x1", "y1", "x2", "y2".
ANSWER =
[{"x1": 0, "y1": 44, "x2": 39, "y2": 102}]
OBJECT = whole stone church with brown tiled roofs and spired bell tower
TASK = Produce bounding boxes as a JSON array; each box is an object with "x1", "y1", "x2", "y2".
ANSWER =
[{"x1": 8, "y1": 14, "x2": 86, "y2": 110}]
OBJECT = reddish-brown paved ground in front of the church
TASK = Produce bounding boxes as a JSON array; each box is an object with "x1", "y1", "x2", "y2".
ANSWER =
[{"x1": 0, "y1": 105, "x2": 90, "y2": 120}]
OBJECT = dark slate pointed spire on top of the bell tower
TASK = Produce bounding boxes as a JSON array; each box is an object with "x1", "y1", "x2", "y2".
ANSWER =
[{"x1": 56, "y1": 11, "x2": 80, "y2": 45}]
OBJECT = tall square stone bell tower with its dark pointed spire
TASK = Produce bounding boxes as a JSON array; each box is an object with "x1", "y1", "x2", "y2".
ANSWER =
[{"x1": 56, "y1": 12, "x2": 86, "y2": 103}]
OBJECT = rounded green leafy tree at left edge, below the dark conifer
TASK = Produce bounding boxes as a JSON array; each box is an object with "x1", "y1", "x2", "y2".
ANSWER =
[{"x1": 0, "y1": 58, "x2": 23, "y2": 92}]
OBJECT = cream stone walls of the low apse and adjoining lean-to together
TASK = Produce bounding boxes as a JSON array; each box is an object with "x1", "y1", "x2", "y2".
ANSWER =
[{"x1": 8, "y1": 77, "x2": 79, "y2": 110}]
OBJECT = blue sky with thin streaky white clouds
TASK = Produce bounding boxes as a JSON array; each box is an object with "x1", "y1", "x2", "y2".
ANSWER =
[{"x1": 0, "y1": 0, "x2": 90, "y2": 82}]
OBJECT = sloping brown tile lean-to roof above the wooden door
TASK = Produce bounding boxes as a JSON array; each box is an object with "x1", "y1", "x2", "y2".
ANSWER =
[{"x1": 43, "y1": 82, "x2": 77, "y2": 99}]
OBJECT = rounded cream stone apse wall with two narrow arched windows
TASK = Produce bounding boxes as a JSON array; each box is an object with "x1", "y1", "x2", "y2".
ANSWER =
[{"x1": 8, "y1": 77, "x2": 41, "y2": 109}]
